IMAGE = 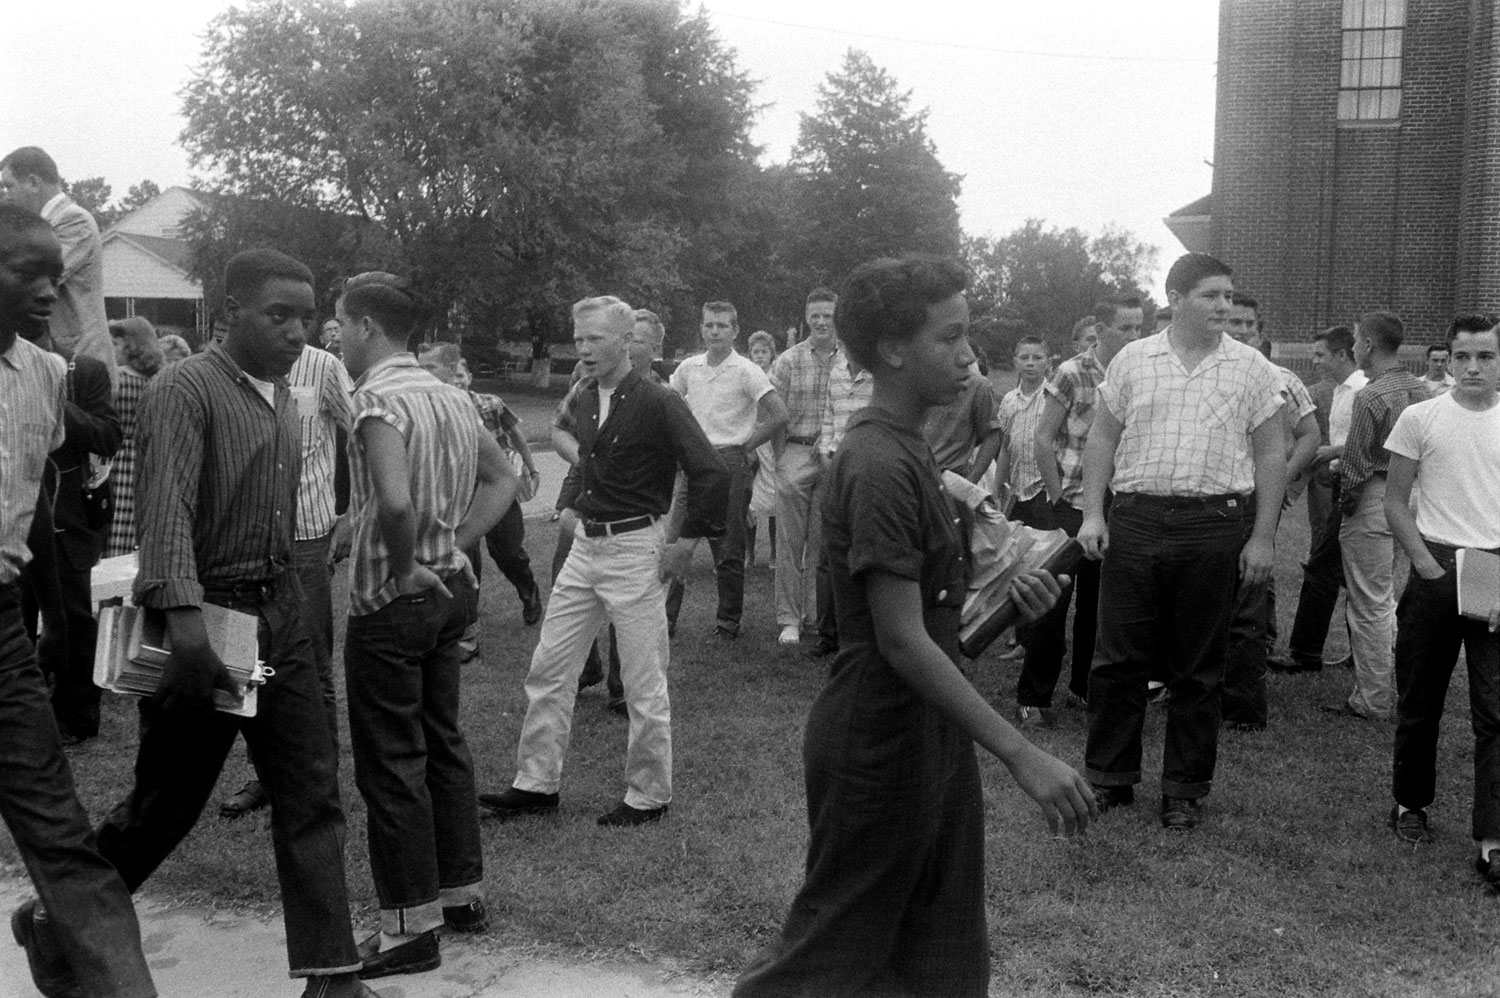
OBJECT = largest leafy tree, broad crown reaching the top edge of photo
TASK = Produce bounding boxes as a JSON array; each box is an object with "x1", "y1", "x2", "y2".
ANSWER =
[{"x1": 183, "y1": 0, "x2": 753, "y2": 349}]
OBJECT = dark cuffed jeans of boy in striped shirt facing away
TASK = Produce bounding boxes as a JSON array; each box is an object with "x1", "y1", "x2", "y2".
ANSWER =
[{"x1": 344, "y1": 575, "x2": 483, "y2": 911}]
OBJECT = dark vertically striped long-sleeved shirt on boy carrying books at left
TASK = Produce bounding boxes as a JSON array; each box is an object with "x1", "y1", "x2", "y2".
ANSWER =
[{"x1": 135, "y1": 344, "x2": 302, "y2": 609}]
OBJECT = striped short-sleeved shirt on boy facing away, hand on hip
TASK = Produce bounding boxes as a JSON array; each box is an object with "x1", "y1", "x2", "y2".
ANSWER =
[{"x1": 350, "y1": 353, "x2": 485, "y2": 617}]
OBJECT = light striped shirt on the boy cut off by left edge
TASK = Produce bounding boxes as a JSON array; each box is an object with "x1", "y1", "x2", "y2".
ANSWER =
[{"x1": 0, "y1": 336, "x2": 68, "y2": 584}]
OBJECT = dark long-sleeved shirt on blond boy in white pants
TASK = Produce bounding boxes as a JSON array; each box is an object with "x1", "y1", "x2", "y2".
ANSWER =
[{"x1": 569, "y1": 371, "x2": 729, "y2": 537}]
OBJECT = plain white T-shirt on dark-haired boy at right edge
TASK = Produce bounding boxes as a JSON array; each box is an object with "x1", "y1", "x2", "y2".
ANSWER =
[{"x1": 1386, "y1": 393, "x2": 1500, "y2": 548}]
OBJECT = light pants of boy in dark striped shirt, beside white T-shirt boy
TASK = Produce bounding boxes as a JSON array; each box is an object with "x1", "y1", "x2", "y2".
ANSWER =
[{"x1": 1338, "y1": 476, "x2": 1397, "y2": 717}]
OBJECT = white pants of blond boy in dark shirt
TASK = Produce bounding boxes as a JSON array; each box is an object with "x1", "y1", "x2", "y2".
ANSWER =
[{"x1": 515, "y1": 519, "x2": 672, "y2": 809}]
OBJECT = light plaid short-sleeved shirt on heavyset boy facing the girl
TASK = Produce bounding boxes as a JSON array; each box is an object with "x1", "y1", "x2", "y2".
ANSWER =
[{"x1": 1100, "y1": 326, "x2": 1284, "y2": 495}]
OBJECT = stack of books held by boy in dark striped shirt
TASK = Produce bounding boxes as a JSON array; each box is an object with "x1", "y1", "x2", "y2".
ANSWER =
[{"x1": 95, "y1": 603, "x2": 275, "y2": 717}]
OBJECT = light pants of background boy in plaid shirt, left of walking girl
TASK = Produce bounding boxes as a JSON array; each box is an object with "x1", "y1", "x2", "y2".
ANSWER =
[{"x1": 776, "y1": 444, "x2": 824, "y2": 627}]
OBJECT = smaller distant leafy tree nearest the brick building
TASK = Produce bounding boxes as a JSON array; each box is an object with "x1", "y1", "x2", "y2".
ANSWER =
[{"x1": 963, "y1": 219, "x2": 1157, "y2": 360}]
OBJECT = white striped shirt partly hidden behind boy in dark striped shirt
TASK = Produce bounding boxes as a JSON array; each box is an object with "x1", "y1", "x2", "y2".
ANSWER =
[{"x1": 287, "y1": 347, "x2": 354, "y2": 540}]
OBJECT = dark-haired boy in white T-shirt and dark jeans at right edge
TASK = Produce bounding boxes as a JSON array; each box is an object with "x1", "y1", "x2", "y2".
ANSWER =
[{"x1": 1386, "y1": 315, "x2": 1500, "y2": 891}]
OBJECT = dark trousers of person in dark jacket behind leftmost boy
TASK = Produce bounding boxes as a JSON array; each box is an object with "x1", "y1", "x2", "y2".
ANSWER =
[{"x1": 23, "y1": 555, "x2": 101, "y2": 738}]
